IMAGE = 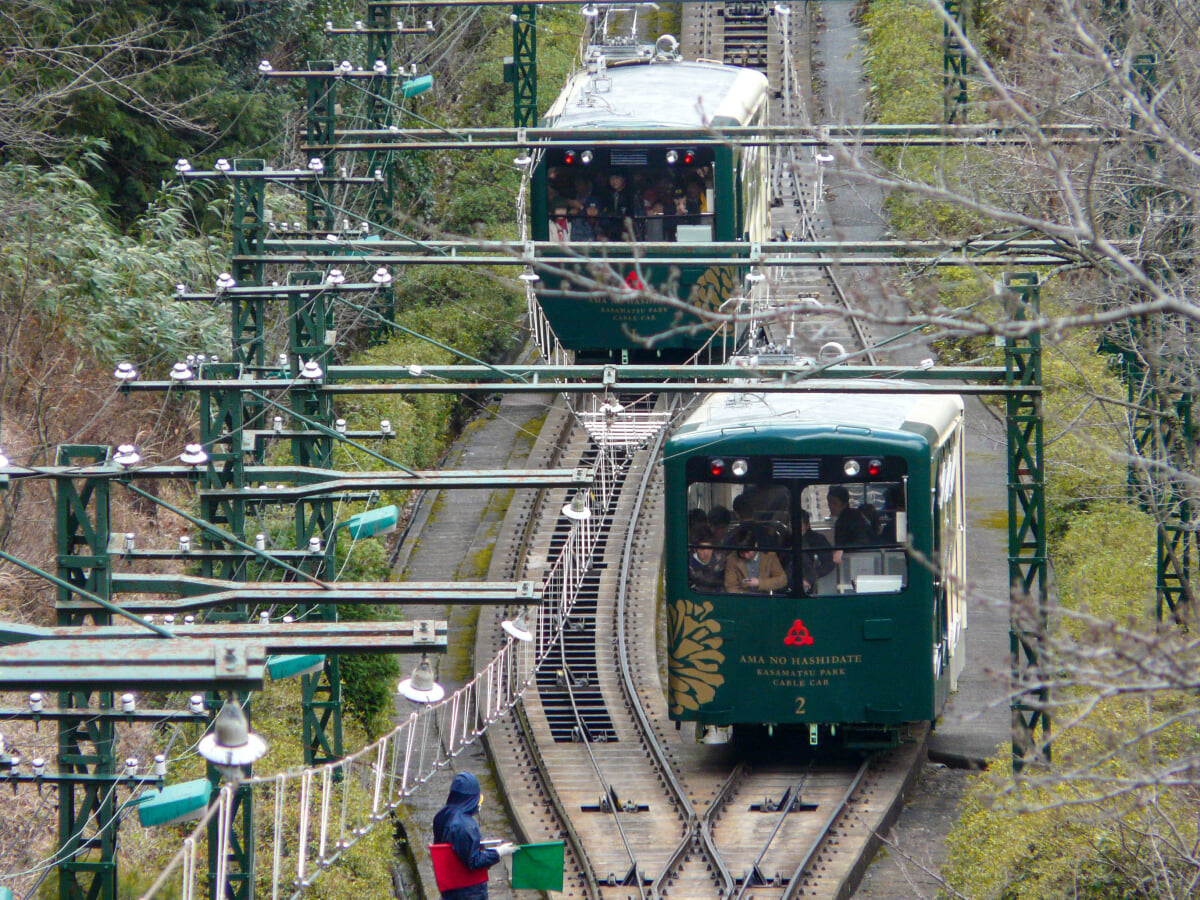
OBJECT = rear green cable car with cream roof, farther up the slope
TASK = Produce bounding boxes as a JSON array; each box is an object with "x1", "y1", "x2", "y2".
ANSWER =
[{"x1": 530, "y1": 36, "x2": 769, "y2": 364}]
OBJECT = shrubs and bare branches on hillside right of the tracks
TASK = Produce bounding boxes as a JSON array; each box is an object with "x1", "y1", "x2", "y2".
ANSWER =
[{"x1": 864, "y1": 0, "x2": 1200, "y2": 900}]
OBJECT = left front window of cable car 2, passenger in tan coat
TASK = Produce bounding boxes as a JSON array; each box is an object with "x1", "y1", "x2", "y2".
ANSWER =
[{"x1": 688, "y1": 481, "x2": 794, "y2": 594}]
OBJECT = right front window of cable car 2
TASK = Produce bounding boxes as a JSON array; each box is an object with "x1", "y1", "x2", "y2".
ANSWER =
[{"x1": 799, "y1": 481, "x2": 908, "y2": 595}]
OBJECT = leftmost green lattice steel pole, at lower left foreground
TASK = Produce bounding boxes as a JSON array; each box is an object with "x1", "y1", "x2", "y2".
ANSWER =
[{"x1": 54, "y1": 446, "x2": 118, "y2": 900}]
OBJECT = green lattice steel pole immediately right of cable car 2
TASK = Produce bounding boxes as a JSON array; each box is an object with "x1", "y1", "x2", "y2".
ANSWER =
[{"x1": 1004, "y1": 272, "x2": 1050, "y2": 772}]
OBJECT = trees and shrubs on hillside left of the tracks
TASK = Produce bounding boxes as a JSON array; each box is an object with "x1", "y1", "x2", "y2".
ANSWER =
[{"x1": 0, "y1": 0, "x2": 580, "y2": 900}]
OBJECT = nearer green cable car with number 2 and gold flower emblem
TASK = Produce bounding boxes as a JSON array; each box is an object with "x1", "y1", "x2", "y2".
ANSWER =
[{"x1": 664, "y1": 382, "x2": 967, "y2": 746}]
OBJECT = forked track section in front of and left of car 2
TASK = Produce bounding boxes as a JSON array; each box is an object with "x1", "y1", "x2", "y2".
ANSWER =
[{"x1": 484, "y1": 381, "x2": 923, "y2": 900}]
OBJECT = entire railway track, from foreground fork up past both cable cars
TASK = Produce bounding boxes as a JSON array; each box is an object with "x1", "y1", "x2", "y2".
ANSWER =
[{"x1": 480, "y1": 2, "x2": 926, "y2": 900}]
